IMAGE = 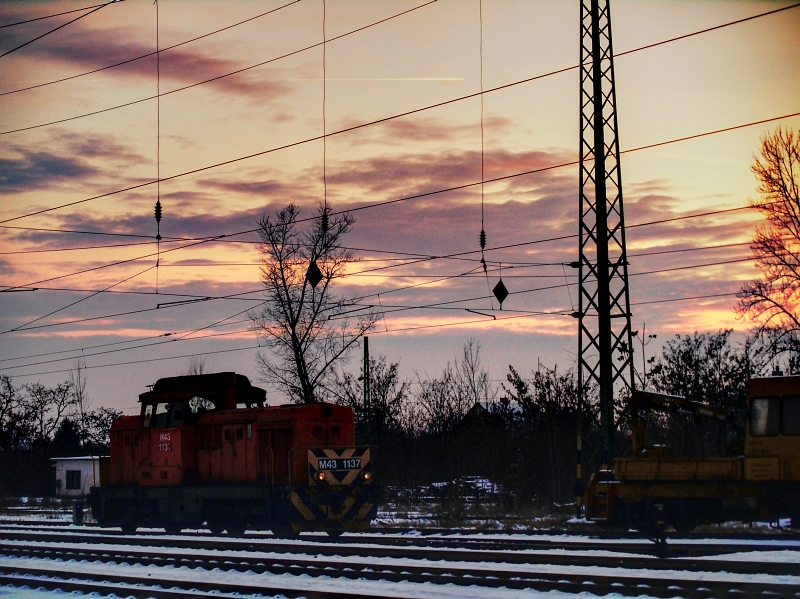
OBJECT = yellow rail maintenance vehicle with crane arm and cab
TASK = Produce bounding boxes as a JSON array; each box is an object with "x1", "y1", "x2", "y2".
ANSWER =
[{"x1": 585, "y1": 376, "x2": 800, "y2": 532}]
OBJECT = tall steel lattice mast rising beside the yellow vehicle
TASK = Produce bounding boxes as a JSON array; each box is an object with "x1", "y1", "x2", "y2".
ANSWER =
[{"x1": 572, "y1": 0, "x2": 634, "y2": 502}]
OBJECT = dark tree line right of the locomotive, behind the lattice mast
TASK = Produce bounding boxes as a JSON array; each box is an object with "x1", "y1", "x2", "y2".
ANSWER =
[{"x1": 329, "y1": 330, "x2": 784, "y2": 507}]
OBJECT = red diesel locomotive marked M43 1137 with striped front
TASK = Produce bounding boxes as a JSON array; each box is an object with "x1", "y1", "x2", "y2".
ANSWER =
[{"x1": 88, "y1": 372, "x2": 379, "y2": 536}]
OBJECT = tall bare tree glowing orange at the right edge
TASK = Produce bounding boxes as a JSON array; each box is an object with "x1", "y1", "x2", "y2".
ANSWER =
[{"x1": 737, "y1": 127, "x2": 800, "y2": 334}]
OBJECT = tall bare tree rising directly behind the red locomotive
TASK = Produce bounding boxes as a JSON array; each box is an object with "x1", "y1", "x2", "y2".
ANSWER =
[{"x1": 250, "y1": 204, "x2": 377, "y2": 403}]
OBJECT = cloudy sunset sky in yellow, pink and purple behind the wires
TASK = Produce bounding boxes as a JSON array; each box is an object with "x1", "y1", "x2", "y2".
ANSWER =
[{"x1": 0, "y1": 0, "x2": 800, "y2": 412}]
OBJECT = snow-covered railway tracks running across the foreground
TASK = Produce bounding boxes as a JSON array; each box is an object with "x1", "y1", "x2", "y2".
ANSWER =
[{"x1": 0, "y1": 531, "x2": 800, "y2": 599}]
